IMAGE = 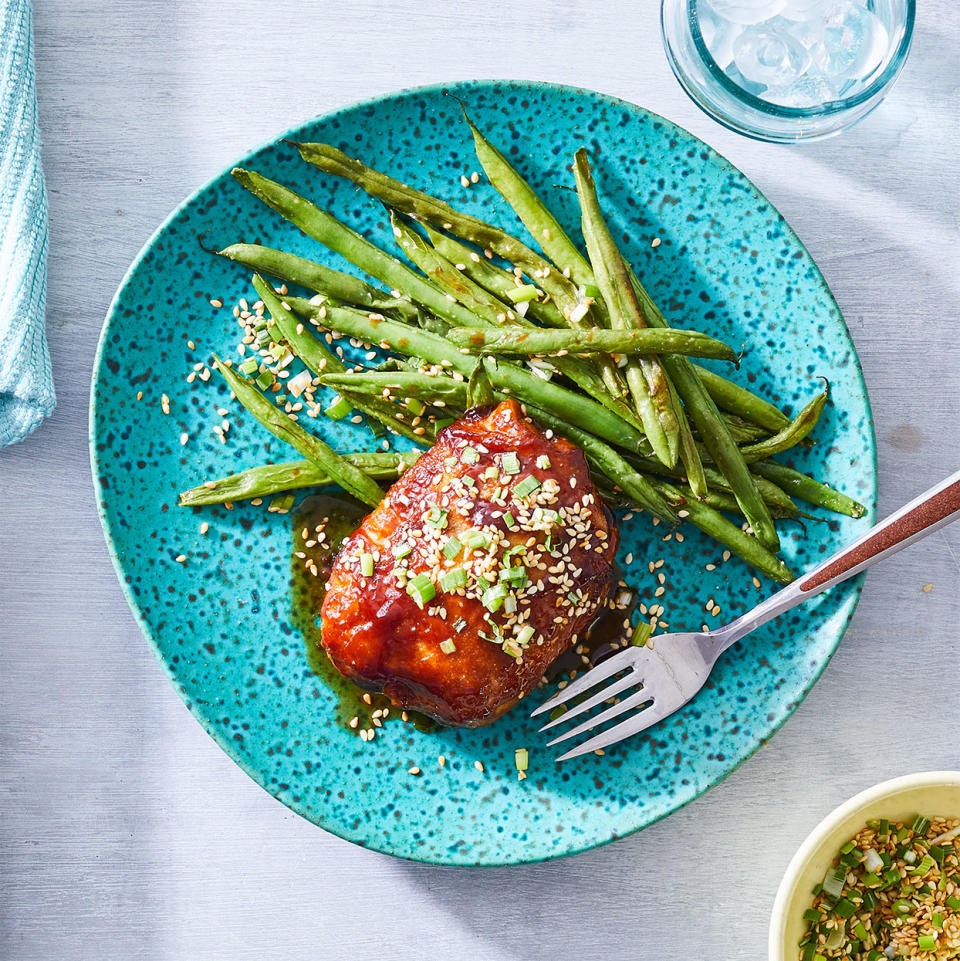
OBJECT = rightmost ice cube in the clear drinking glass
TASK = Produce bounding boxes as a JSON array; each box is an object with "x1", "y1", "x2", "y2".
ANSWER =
[{"x1": 812, "y1": 0, "x2": 890, "y2": 81}]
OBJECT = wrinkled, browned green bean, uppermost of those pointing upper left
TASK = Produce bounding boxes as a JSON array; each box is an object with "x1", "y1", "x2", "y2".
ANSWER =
[{"x1": 296, "y1": 143, "x2": 579, "y2": 317}]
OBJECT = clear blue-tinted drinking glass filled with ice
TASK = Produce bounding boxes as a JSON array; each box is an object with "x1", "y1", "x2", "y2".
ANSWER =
[{"x1": 661, "y1": 0, "x2": 916, "y2": 143}]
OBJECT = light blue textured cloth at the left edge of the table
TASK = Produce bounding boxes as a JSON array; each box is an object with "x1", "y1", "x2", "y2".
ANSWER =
[{"x1": 0, "y1": 0, "x2": 56, "y2": 447}]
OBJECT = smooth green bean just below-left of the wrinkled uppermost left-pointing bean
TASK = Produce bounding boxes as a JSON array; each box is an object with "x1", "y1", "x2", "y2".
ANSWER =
[{"x1": 233, "y1": 167, "x2": 484, "y2": 336}]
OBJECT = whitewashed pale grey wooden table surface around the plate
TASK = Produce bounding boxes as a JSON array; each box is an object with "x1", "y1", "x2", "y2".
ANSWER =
[{"x1": 0, "y1": 0, "x2": 960, "y2": 961}]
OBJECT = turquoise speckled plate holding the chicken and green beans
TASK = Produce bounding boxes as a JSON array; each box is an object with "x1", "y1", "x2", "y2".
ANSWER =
[{"x1": 90, "y1": 81, "x2": 876, "y2": 864}]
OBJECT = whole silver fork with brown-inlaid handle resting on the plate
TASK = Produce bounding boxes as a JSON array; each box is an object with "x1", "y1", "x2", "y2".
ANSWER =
[{"x1": 531, "y1": 471, "x2": 960, "y2": 761}]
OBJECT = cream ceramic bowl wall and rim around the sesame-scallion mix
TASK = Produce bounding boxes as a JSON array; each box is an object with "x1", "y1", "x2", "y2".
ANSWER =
[{"x1": 768, "y1": 771, "x2": 960, "y2": 961}]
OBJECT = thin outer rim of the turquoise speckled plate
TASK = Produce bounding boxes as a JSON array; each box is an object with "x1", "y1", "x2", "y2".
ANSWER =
[{"x1": 87, "y1": 78, "x2": 878, "y2": 867}]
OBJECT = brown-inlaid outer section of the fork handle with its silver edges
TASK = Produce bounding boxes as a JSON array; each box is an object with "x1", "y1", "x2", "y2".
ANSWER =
[{"x1": 797, "y1": 471, "x2": 960, "y2": 594}]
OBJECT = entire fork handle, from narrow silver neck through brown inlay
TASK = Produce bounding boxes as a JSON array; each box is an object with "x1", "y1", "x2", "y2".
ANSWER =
[{"x1": 711, "y1": 471, "x2": 960, "y2": 654}]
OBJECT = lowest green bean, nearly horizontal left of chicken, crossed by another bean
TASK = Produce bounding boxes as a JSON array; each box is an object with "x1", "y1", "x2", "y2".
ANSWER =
[{"x1": 180, "y1": 450, "x2": 421, "y2": 507}]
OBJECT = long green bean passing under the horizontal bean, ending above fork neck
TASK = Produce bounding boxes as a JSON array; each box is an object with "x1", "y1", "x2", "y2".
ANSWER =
[{"x1": 630, "y1": 270, "x2": 780, "y2": 552}]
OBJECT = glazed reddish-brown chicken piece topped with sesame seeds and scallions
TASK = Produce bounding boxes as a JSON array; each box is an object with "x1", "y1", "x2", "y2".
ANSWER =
[{"x1": 321, "y1": 400, "x2": 617, "y2": 727}]
